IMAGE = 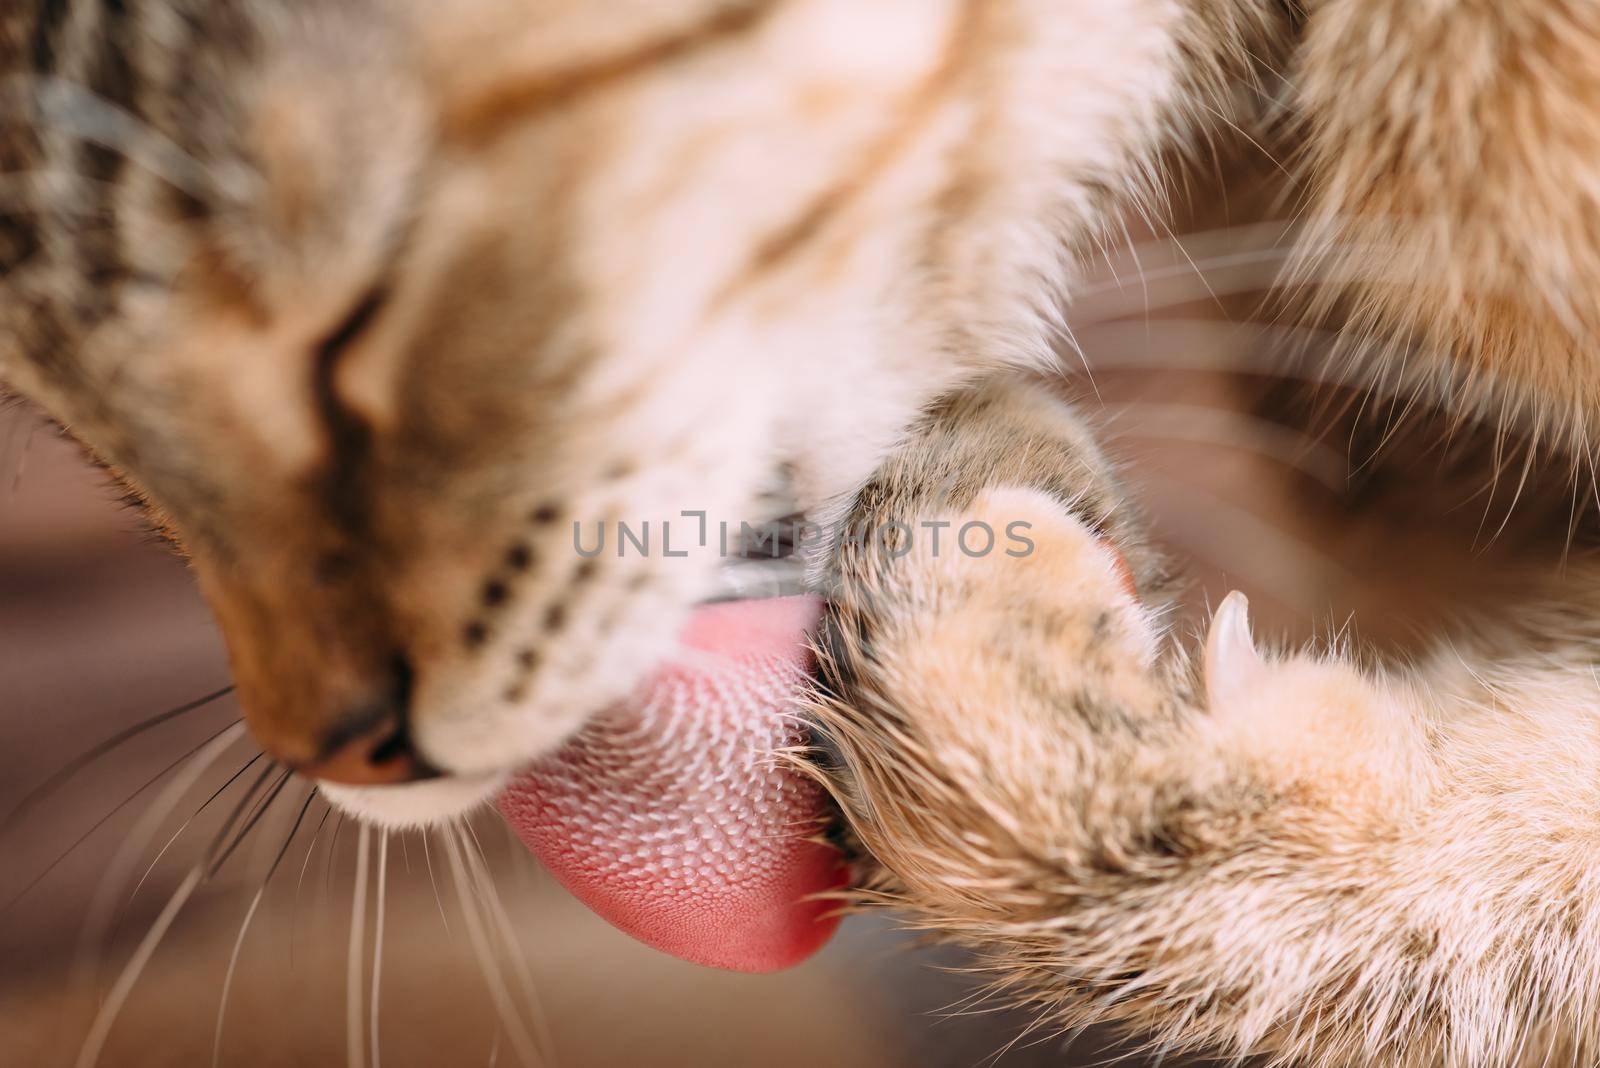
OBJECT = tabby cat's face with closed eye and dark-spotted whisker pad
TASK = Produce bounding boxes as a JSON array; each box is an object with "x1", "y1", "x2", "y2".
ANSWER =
[{"x1": 0, "y1": 0, "x2": 962, "y2": 807}]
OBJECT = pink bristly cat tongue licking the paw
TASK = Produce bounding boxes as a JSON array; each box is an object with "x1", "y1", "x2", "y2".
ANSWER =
[{"x1": 499, "y1": 596, "x2": 845, "y2": 972}]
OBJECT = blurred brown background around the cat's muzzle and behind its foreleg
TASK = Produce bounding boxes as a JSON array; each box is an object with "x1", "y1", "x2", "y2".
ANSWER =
[{"x1": 0, "y1": 202, "x2": 1561, "y2": 1068}]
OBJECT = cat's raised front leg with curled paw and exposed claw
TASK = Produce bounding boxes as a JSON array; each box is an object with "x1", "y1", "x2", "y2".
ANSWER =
[{"x1": 810, "y1": 382, "x2": 1600, "y2": 1068}]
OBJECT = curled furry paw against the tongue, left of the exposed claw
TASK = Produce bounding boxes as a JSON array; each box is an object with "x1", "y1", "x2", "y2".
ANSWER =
[{"x1": 808, "y1": 488, "x2": 1184, "y2": 915}]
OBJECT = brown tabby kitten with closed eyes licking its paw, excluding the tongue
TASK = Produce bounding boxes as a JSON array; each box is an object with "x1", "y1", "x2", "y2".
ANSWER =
[{"x1": 9, "y1": 0, "x2": 1600, "y2": 1063}]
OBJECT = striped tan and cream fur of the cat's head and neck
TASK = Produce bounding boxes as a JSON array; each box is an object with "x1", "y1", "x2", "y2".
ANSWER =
[{"x1": 0, "y1": 0, "x2": 1270, "y2": 808}]
